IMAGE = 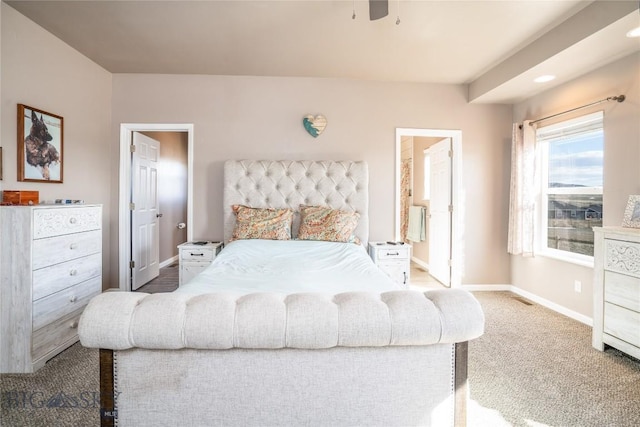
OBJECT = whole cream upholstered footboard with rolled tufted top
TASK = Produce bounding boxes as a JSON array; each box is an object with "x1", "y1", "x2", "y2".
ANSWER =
[{"x1": 79, "y1": 290, "x2": 484, "y2": 426}]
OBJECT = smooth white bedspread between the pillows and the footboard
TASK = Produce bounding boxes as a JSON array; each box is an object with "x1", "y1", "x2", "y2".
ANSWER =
[{"x1": 176, "y1": 240, "x2": 400, "y2": 294}]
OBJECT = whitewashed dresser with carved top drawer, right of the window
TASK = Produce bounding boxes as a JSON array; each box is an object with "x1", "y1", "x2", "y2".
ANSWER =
[{"x1": 592, "y1": 227, "x2": 640, "y2": 359}]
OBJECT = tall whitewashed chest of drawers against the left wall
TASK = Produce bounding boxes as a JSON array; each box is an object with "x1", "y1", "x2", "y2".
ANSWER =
[{"x1": 0, "y1": 205, "x2": 102, "y2": 373}]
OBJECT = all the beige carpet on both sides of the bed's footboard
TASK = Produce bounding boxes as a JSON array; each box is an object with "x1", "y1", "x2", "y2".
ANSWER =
[{"x1": 0, "y1": 292, "x2": 640, "y2": 427}]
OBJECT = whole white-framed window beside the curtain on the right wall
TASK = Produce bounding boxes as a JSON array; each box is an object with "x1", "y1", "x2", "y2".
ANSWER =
[{"x1": 536, "y1": 112, "x2": 604, "y2": 262}]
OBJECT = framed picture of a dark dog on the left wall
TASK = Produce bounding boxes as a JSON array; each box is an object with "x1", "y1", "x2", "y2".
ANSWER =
[{"x1": 18, "y1": 104, "x2": 64, "y2": 183}]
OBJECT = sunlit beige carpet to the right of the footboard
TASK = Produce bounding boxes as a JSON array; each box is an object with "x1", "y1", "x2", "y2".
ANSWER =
[{"x1": 468, "y1": 292, "x2": 640, "y2": 427}]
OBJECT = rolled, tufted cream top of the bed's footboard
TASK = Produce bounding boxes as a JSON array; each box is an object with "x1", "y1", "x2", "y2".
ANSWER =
[{"x1": 78, "y1": 290, "x2": 484, "y2": 350}]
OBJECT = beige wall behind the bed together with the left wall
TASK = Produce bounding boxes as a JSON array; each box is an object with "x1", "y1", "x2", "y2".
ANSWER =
[{"x1": 1, "y1": 3, "x2": 512, "y2": 286}]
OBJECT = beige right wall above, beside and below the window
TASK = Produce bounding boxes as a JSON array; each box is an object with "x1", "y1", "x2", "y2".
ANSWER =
[{"x1": 511, "y1": 53, "x2": 640, "y2": 317}]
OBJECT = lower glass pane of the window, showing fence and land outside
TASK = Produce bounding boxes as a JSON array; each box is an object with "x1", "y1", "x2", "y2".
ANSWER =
[{"x1": 547, "y1": 194, "x2": 602, "y2": 256}]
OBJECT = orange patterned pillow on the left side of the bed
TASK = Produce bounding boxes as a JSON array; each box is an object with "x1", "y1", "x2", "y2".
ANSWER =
[{"x1": 231, "y1": 205, "x2": 293, "y2": 240}]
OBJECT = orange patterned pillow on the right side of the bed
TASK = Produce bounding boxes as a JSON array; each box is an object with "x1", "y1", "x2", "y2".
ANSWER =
[{"x1": 298, "y1": 205, "x2": 360, "y2": 244}]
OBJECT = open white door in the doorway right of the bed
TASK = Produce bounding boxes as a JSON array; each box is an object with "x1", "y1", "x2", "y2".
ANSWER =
[{"x1": 428, "y1": 138, "x2": 452, "y2": 286}]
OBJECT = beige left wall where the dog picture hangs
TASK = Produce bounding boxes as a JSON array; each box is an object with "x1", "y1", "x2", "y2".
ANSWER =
[{"x1": 0, "y1": 3, "x2": 117, "y2": 286}]
